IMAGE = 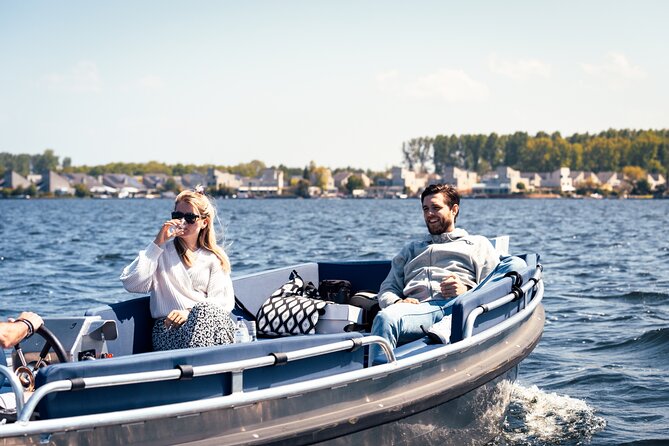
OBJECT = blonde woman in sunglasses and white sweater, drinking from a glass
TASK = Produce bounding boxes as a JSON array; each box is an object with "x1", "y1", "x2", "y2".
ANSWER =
[{"x1": 121, "y1": 187, "x2": 235, "y2": 350}]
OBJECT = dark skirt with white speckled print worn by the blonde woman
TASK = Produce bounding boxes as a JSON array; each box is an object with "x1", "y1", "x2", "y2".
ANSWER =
[{"x1": 151, "y1": 303, "x2": 235, "y2": 351}]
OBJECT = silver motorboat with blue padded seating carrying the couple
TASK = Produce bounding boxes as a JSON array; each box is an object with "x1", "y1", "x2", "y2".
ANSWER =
[{"x1": 0, "y1": 237, "x2": 544, "y2": 446}]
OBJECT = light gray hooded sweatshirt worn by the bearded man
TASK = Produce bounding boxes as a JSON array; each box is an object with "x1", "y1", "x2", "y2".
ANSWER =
[{"x1": 379, "y1": 229, "x2": 499, "y2": 308}]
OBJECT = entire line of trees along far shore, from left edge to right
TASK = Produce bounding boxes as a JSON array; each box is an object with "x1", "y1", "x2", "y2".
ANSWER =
[{"x1": 5, "y1": 129, "x2": 669, "y2": 183}]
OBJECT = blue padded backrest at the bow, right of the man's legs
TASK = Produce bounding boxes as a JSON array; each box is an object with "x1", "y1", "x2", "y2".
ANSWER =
[{"x1": 451, "y1": 254, "x2": 539, "y2": 343}]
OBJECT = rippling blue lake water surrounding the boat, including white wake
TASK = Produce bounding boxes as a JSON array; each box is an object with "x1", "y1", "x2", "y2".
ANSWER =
[{"x1": 0, "y1": 199, "x2": 669, "y2": 445}]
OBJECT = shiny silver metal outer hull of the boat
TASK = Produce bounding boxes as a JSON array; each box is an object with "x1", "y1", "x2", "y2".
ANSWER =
[{"x1": 0, "y1": 305, "x2": 544, "y2": 446}]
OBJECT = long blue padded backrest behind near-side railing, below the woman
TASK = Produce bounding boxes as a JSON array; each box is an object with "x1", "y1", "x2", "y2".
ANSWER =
[{"x1": 36, "y1": 333, "x2": 365, "y2": 419}]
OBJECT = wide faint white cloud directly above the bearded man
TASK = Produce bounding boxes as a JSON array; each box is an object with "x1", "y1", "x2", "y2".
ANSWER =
[{"x1": 376, "y1": 68, "x2": 489, "y2": 102}]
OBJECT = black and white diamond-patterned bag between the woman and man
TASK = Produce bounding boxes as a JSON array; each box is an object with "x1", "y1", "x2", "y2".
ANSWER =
[{"x1": 256, "y1": 271, "x2": 327, "y2": 336}]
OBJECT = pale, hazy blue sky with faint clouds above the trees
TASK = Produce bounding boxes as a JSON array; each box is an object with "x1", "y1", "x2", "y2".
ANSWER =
[{"x1": 0, "y1": 0, "x2": 669, "y2": 170}]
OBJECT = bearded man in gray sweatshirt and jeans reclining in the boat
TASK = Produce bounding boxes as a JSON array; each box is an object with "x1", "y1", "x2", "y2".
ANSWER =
[{"x1": 370, "y1": 184, "x2": 500, "y2": 363}]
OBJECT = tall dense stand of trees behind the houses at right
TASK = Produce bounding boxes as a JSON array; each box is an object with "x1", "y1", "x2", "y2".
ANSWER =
[{"x1": 402, "y1": 129, "x2": 669, "y2": 175}]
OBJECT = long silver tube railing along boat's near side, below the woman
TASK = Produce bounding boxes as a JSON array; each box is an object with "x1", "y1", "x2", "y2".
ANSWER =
[{"x1": 13, "y1": 336, "x2": 396, "y2": 423}]
